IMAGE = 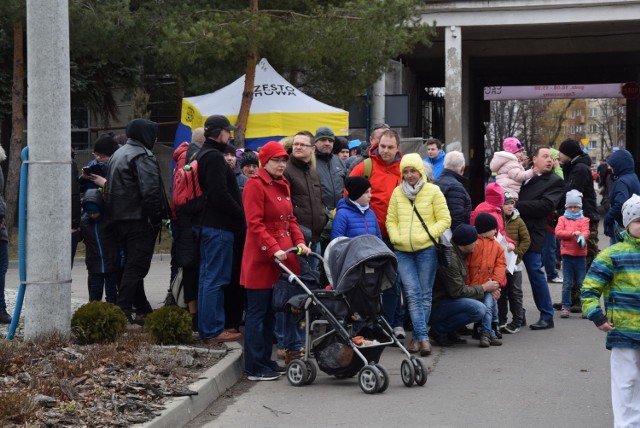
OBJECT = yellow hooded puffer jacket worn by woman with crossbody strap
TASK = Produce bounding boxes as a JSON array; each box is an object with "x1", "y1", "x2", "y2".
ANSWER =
[{"x1": 386, "y1": 153, "x2": 451, "y2": 252}]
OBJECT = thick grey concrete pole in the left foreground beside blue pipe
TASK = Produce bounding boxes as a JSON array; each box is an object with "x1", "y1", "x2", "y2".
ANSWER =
[{"x1": 24, "y1": 0, "x2": 71, "y2": 339}]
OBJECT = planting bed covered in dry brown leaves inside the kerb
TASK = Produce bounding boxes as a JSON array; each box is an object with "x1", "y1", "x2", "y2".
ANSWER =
[{"x1": 0, "y1": 329, "x2": 227, "y2": 427}]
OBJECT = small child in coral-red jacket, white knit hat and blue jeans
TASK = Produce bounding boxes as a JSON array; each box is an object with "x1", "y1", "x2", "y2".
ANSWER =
[{"x1": 556, "y1": 189, "x2": 589, "y2": 318}]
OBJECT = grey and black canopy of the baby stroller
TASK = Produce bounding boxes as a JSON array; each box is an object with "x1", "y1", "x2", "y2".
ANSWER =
[{"x1": 325, "y1": 235, "x2": 398, "y2": 293}]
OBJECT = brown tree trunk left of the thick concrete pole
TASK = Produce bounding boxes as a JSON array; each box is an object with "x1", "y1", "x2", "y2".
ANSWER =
[{"x1": 5, "y1": 22, "x2": 25, "y2": 233}]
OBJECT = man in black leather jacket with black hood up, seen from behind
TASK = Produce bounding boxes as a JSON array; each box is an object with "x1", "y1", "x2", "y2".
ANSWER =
[{"x1": 104, "y1": 119, "x2": 168, "y2": 324}]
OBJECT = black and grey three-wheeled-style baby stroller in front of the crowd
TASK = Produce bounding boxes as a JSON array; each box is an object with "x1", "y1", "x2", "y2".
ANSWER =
[{"x1": 276, "y1": 235, "x2": 427, "y2": 394}]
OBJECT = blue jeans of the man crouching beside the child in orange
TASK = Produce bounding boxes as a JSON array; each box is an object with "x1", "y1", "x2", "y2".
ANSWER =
[{"x1": 431, "y1": 297, "x2": 487, "y2": 336}]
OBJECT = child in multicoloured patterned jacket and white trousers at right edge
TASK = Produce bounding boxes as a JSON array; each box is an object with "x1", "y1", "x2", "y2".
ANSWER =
[{"x1": 580, "y1": 195, "x2": 640, "y2": 427}]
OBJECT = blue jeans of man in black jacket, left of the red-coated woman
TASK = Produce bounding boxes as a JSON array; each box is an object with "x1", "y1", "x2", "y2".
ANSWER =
[{"x1": 196, "y1": 227, "x2": 235, "y2": 339}]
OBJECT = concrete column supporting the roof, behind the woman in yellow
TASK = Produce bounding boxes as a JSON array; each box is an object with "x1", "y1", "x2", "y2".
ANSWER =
[{"x1": 443, "y1": 25, "x2": 460, "y2": 151}]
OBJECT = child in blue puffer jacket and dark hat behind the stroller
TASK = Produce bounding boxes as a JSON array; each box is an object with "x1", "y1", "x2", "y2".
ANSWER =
[{"x1": 331, "y1": 176, "x2": 382, "y2": 240}]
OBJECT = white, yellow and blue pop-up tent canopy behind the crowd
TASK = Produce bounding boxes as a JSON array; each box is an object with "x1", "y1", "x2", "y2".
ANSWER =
[{"x1": 175, "y1": 58, "x2": 349, "y2": 150}]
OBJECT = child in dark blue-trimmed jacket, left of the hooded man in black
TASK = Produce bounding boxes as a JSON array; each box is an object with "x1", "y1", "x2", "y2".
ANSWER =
[{"x1": 80, "y1": 189, "x2": 120, "y2": 304}]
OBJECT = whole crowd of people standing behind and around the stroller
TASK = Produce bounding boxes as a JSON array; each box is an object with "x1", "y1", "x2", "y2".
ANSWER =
[{"x1": 0, "y1": 115, "x2": 640, "y2": 417}]
